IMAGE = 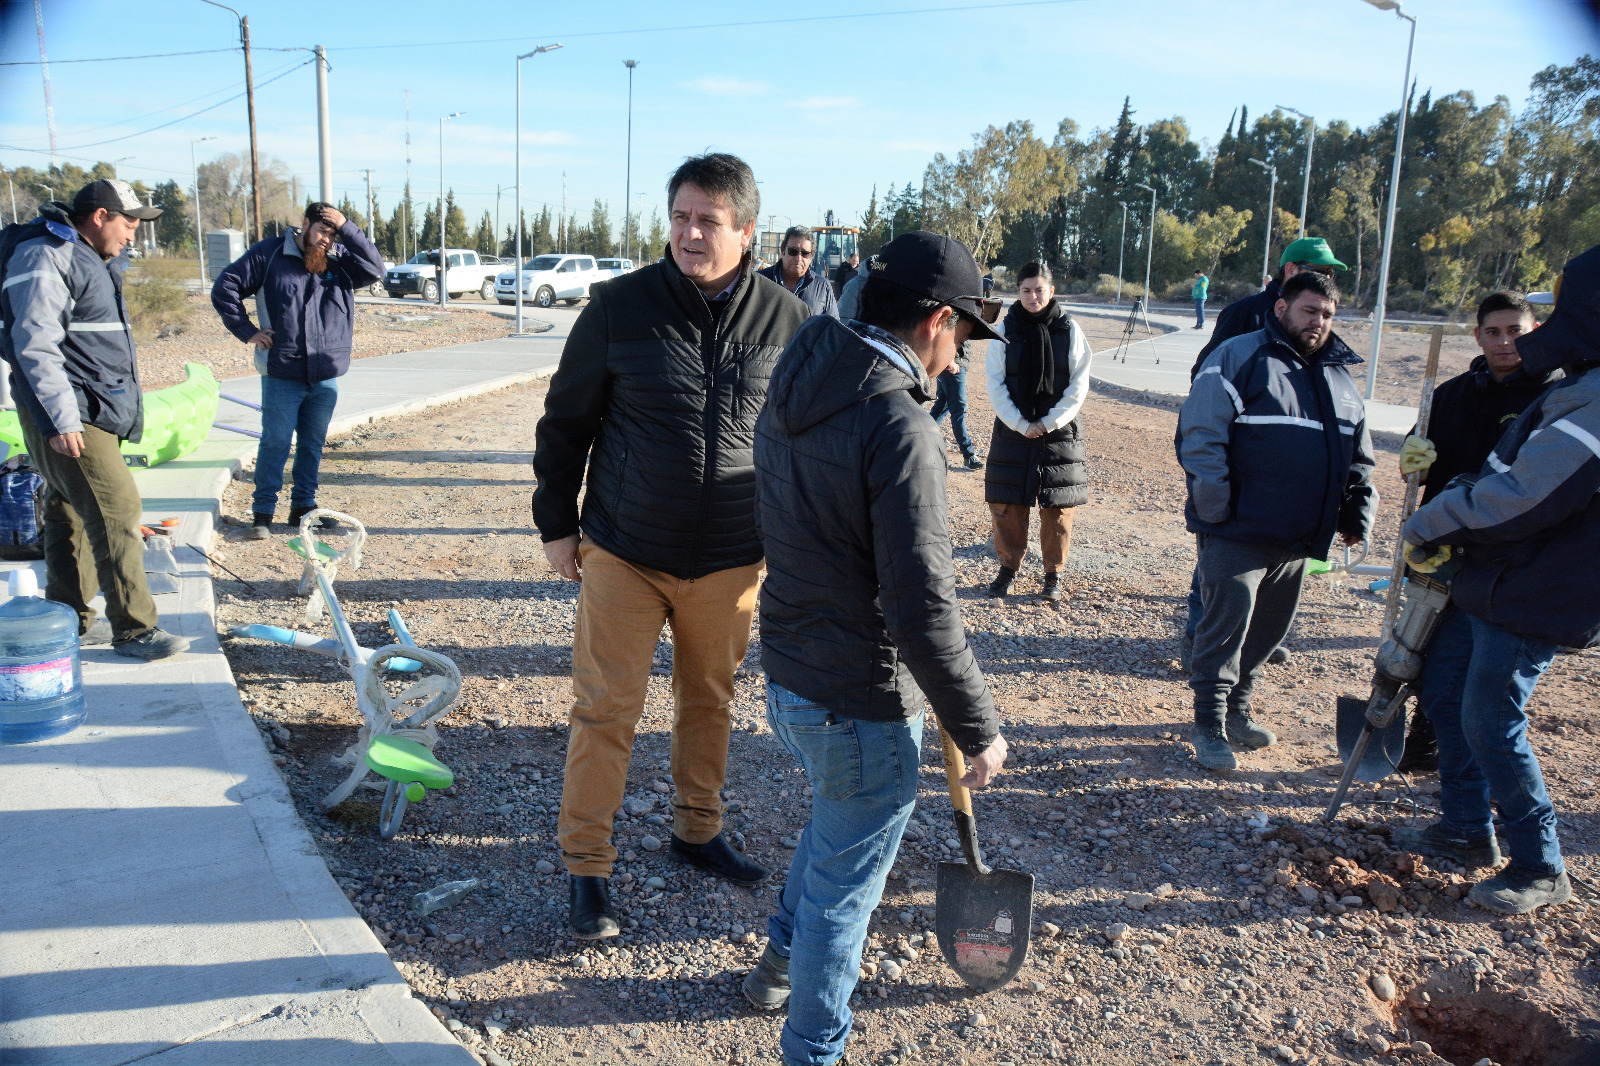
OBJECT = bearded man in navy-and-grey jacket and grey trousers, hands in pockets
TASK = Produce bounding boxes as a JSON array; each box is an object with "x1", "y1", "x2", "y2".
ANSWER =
[{"x1": 1178, "y1": 272, "x2": 1378, "y2": 770}]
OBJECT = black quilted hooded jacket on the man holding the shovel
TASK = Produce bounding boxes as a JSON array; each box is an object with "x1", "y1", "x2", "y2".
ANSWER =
[{"x1": 755, "y1": 315, "x2": 1000, "y2": 755}]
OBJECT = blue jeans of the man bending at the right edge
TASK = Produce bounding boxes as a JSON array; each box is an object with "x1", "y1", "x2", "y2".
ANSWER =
[{"x1": 1418, "y1": 610, "x2": 1565, "y2": 877}]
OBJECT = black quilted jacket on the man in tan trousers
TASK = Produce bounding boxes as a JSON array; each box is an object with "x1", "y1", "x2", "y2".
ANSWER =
[{"x1": 533, "y1": 251, "x2": 810, "y2": 581}]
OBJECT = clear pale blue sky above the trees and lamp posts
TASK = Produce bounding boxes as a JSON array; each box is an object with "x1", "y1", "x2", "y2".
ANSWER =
[{"x1": 0, "y1": 0, "x2": 1600, "y2": 236}]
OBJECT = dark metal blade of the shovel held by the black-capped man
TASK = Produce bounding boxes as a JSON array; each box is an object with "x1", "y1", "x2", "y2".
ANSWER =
[{"x1": 933, "y1": 863, "x2": 1034, "y2": 992}]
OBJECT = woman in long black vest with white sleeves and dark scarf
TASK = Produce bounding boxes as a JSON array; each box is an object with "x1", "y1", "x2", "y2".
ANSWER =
[{"x1": 984, "y1": 262, "x2": 1090, "y2": 603}]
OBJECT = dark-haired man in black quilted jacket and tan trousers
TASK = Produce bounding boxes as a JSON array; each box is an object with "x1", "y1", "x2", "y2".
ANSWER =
[{"x1": 533, "y1": 154, "x2": 810, "y2": 940}]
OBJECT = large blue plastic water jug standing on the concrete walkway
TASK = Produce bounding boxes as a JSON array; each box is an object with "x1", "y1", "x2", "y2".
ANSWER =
[{"x1": 0, "y1": 568, "x2": 85, "y2": 744}]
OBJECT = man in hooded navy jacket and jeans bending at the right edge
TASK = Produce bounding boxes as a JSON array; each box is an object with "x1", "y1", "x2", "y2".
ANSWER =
[{"x1": 1390, "y1": 248, "x2": 1600, "y2": 914}]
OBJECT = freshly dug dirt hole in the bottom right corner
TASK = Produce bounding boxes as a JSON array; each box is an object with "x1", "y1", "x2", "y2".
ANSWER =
[{"x1": 1397, "y1": 983, "x2": 1600, "y2": 1066}]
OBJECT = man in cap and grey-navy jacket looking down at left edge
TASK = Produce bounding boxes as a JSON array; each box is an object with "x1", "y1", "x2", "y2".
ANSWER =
[{"x1": 0, "y1": 181, "x2": 189, "y2": 659}]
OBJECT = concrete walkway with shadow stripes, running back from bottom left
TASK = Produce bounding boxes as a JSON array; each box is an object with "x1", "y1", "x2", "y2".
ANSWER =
[{"x1": 0, "y1": 320, "x2": 576, "y2": 1066}]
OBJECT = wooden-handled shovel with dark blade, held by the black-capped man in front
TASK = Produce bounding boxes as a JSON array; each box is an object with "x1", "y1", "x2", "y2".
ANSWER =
[{"x1": 933, "y1": 727, "x2": 1034, "y2": 992}]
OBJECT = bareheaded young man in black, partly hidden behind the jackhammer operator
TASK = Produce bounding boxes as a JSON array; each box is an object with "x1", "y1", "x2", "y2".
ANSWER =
[{"x1": 1400, "y1": 291, "x2": 1562, "y2": 773}]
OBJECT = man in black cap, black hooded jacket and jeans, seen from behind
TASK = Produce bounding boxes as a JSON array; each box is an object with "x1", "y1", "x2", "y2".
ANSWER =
[{"x1": 744, "y1": 232, "x2": 1006, "y2": 1066}]
